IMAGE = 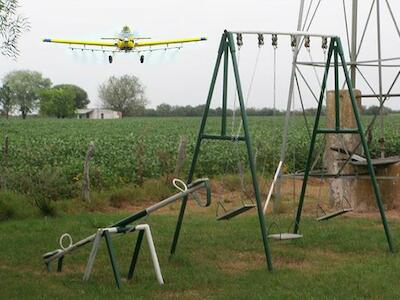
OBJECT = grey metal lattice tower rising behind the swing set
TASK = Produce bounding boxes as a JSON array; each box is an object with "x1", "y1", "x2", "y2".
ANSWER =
[{"x1": 281, "y1": 0, "x2": 400, "y2": 161}]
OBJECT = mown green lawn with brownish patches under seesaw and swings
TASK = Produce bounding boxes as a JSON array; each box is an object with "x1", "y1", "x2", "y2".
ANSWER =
[{"x1": 0, "y1": 206, "x2": 400, "y2": 299}]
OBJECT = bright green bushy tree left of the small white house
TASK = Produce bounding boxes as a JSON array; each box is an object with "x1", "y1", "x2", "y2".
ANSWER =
[{"x1": 40, "y1": 88, "x2": 75, "y2": 118}]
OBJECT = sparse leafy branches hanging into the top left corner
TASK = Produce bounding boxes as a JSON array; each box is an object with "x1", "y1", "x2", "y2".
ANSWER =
[{"x1": 0, "y1": 0, "x2": 29, "y2": 59}]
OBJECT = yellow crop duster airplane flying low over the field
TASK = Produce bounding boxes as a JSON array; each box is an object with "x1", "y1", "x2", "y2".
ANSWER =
[{"x1": 43, "y1": 26, "x2": 207, "y2": 64}]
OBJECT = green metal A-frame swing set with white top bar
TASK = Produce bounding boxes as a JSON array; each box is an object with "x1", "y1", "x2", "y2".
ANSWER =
[{"x1": 171, "y1": 30, "x2": 394, "y2": 271}]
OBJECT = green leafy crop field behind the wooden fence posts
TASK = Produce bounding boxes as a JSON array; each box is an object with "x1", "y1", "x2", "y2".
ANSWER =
[{"x1": 0, "y1": 115, "x2": 400, "y2": 198}]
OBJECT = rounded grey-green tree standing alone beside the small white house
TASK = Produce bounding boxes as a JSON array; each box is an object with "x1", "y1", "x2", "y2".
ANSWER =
[{"x1": 99, "y1": 75, "x2": 148, "y2": 116}]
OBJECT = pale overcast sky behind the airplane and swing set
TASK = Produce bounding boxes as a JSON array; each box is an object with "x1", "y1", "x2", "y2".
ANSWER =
[{"x1": 0, "y1": 0, "x2": 400, "y2": 109}]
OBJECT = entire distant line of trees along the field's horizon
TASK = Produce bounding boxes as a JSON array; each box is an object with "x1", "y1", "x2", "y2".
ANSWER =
[{"x1": 0, "y1": 70, "x2": 396, "y2": 119}]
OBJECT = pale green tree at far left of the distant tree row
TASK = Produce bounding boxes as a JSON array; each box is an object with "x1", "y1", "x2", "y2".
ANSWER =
[{"x1": 3, "y1": 70, "x2": 51, "y2": 119}]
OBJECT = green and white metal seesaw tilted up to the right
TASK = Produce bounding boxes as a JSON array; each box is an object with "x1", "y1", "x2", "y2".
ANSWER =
[{"x1": 42, "y1": 178, "x2": 211, "y2": 288}]
